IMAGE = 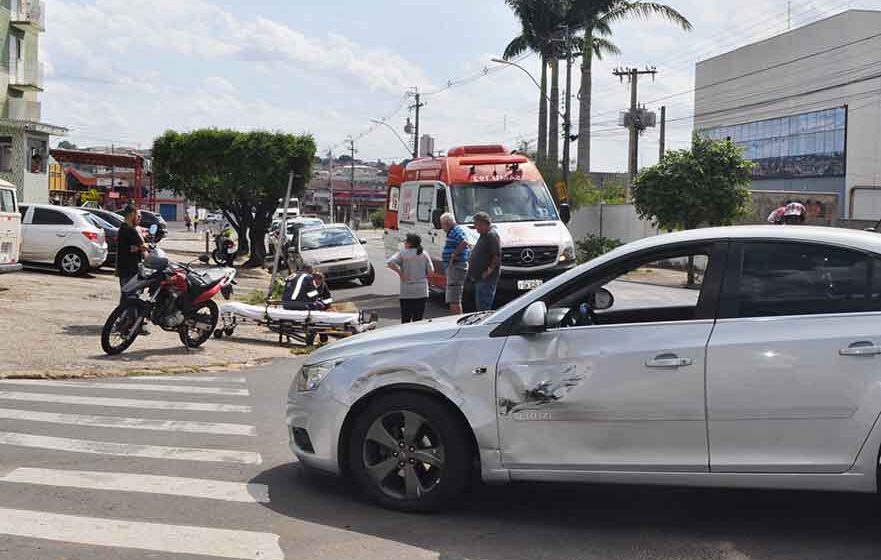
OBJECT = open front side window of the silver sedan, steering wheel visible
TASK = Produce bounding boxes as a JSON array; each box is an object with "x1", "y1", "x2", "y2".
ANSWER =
[{"x1": 546, "y1": 247, "x2": 710, "y2": 328}]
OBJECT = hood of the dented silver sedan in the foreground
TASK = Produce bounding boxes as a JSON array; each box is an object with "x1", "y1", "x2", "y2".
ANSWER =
[{"x1": 306, "y1": 316, "x2": 462, "y2": 364}]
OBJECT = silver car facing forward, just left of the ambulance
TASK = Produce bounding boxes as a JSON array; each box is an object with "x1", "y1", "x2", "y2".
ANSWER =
[{"x1": 288, "y1": 224, "x2": 376, "y2": 286}]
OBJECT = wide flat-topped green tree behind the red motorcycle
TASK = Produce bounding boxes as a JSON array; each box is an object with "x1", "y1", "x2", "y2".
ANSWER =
[{"x1": 153, "y1": 129, "x2": 315, "y2": 266}]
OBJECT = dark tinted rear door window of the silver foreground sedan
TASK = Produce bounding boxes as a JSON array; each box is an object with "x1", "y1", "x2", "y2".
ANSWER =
[{"x1": 726, "y1": 242, "x2": 870, "y2": 317}]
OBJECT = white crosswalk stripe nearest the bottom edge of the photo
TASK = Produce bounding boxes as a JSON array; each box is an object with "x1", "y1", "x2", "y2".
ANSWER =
[{"x1": 0, "y1": 508, "x2": 284, "y2": 560}]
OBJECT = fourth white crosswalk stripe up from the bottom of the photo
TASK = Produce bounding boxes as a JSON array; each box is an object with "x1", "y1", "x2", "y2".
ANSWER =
[{"x1": 0, "y1": 408, "x2": 257, "y2": 436}]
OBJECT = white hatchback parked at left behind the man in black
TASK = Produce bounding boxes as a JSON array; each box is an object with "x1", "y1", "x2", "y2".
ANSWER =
[{"x1": 19, "y1": 204, "x2": 107, "y2": 276}]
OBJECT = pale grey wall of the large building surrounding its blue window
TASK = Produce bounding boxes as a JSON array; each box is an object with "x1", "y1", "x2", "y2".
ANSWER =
[{"x1": 695, "y1": 10, "x2": 881, "y2": 216}]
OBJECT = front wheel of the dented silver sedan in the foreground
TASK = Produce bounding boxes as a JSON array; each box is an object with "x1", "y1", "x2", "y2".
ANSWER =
[{"x1": 348, "y1": 393, "x2": 471, "y2": 511}]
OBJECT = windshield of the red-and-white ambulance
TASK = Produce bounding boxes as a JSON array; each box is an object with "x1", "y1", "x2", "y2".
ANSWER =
[{"x1": 450, "y1": 181, "x2": 558, "y2": 224}]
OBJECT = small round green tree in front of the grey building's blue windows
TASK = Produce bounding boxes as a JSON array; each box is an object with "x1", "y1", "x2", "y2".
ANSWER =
[{"x1": 631, "y1": 133, "x2": 754, "y2": 285}]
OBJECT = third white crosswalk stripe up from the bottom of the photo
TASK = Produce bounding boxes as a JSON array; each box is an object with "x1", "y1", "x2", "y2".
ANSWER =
[{"x1": 0, "y1": 432, "x2": 263, "y2": 465}]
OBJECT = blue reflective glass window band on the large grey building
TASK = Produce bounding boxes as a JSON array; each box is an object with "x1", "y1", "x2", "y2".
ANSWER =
[{"x1": 702, "y1": 107, "x2": 846, "y2": 179}]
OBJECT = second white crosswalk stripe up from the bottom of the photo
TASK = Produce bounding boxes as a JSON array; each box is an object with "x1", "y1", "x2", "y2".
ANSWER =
[{"x1": 0, "y1": 467, "x2": 269, "y2": 503}]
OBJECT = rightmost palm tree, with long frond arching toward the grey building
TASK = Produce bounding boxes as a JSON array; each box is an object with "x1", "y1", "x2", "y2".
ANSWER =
[{"x1": 570, "y1": 0, "x2": 692, "y2": 173}]
